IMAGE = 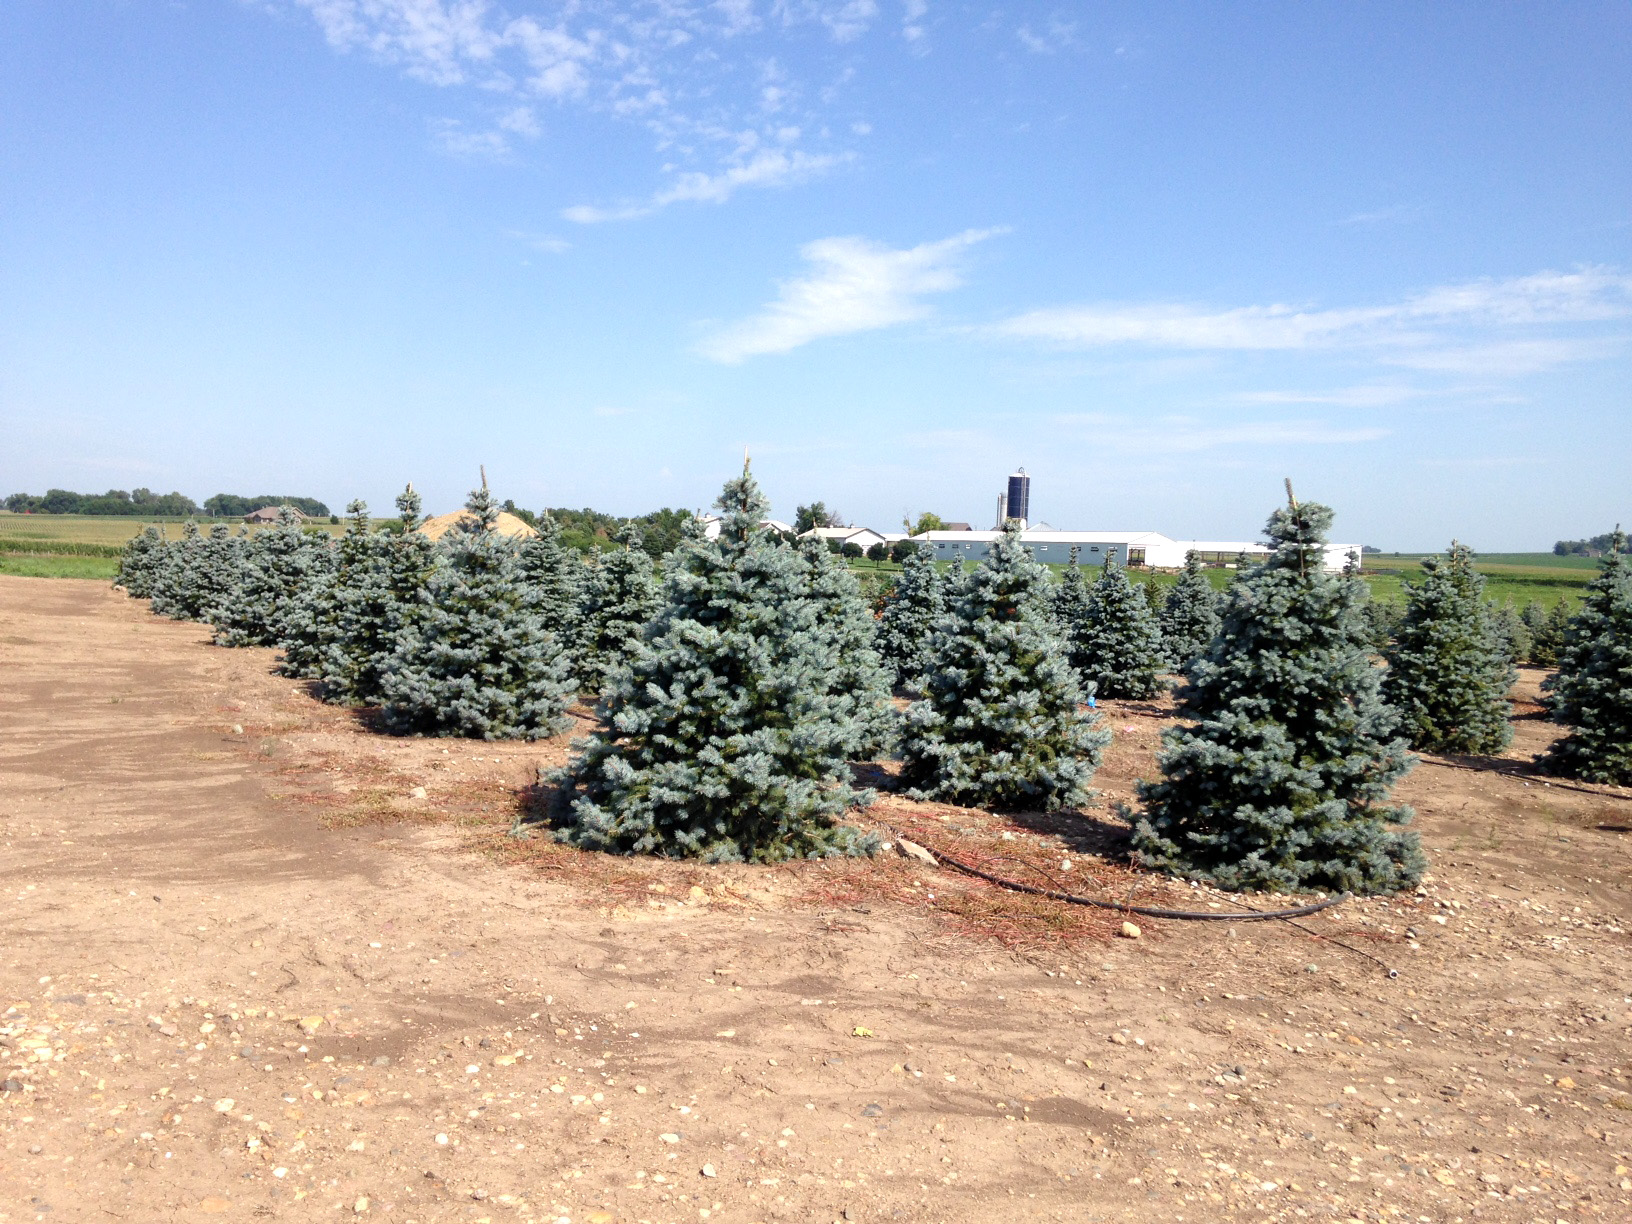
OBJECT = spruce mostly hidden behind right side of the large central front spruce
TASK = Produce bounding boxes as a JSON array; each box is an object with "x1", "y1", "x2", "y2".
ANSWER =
[{"x1": 796, "y1": 539, "x2": 896, "y2": 761}]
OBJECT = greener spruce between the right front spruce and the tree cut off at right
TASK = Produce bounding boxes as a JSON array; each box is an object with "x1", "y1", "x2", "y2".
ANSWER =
[{"x1": 1382, "y1": 540, "x2": 1518, "y2": 752}]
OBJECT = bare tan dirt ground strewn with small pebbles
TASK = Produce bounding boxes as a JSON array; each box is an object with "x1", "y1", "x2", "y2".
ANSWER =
[{"x1": 0, "y1": 578, "x2": 1632, "y2": 1224}]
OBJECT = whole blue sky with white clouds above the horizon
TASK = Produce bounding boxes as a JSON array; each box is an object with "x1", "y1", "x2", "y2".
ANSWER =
[{"x1": 0, "y1": 0, "x2": 1632, "y2": 550}]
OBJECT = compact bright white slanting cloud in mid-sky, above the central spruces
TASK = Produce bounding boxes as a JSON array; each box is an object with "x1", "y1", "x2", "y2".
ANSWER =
[{"x1": 698, "y1": 230, "x2": 1002, "y2": 364}]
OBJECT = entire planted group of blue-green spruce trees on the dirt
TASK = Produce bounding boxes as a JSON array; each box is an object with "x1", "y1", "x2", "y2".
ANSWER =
[{"x1": 121, "y1": 470, "x2": 1632, "y2": 891}]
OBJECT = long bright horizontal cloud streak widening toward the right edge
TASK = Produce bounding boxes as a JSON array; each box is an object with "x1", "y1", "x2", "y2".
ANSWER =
[{"x1": 992, "y1": 268, "x2": 1632, "y2": 372}]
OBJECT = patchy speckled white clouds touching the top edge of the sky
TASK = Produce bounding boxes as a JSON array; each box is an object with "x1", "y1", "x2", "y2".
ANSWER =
[{"x1": 274, "y1": 0, "x2": 894, "y2": 212}]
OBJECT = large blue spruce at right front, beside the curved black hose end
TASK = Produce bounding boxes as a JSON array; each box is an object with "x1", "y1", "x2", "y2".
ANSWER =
[{"x1": 1134, "y1": 483, "x2": 1426, "y2": 893}]
